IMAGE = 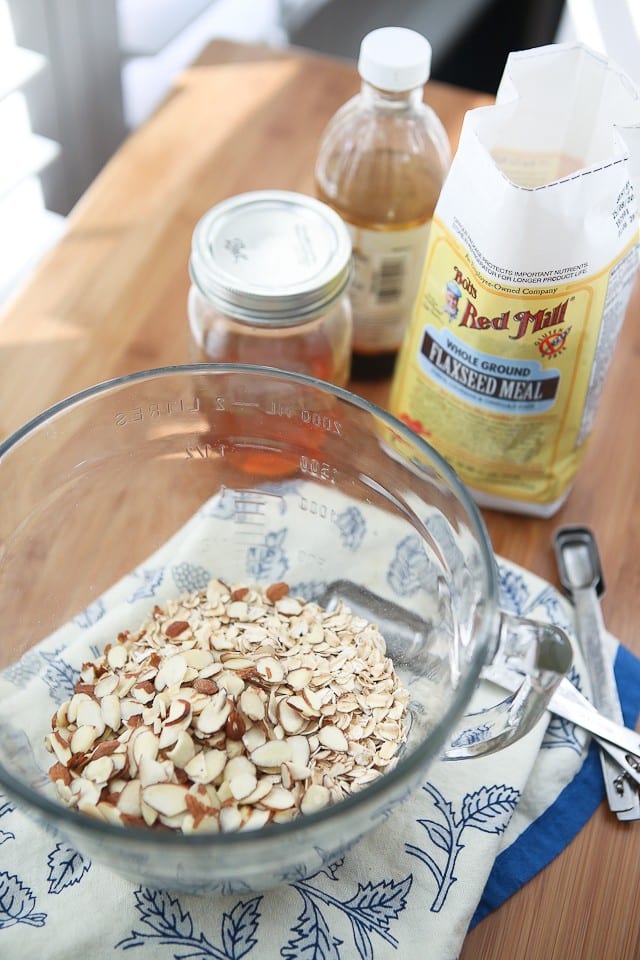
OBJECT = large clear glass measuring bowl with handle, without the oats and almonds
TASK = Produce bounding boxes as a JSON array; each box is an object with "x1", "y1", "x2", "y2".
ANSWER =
[{"x1": 0, "y1": 365, "x2": 569, "y2": 892}]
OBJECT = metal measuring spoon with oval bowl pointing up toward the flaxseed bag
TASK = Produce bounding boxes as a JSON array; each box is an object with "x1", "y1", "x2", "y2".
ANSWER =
[{"x1": 554, "y1": 526, "x2": 640, "y2": 820}]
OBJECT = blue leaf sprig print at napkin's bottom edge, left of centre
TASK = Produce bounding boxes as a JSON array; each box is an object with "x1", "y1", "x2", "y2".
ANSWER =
[{"x1": 116, "y1": 887, "x2": 262, "y2": 960}]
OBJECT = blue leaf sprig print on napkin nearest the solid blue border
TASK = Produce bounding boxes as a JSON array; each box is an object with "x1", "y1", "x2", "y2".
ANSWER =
[{"x1": 405, "y1": 783, "x2": 520, "y2": 913}]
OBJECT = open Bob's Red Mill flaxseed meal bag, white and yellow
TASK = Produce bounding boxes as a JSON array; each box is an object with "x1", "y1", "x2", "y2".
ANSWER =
[{"x1": 391, "y1": 44, "x2": 640, "y2": 516}]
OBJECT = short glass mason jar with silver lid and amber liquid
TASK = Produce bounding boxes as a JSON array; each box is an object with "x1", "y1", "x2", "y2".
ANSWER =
[{"x1": 188, "y1": 190, "x2": 352, "y2": 386}]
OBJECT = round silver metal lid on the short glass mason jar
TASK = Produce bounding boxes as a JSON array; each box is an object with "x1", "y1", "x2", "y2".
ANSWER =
[{"x1": 189, "y1": 190, "x2": 351, "y2": 325}]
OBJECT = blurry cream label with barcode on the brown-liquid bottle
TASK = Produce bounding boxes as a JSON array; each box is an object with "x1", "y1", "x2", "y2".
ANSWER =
[{"x1": 347, "y1": 221, "x2": 430, "y2": 353}]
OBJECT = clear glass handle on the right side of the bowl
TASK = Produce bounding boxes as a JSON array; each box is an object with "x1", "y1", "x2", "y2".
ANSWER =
[{"x1": 443, "y1": 612, "x2": 573, "y2": 760}]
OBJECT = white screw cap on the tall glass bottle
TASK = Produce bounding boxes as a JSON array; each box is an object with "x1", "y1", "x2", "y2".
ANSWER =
[{"x1": 358, "y1": 27, "x2": 431, "y2": 92}]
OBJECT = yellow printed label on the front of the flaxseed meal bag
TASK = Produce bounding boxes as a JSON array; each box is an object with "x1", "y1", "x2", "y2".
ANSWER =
[{"x1": 391, "y1": 218, "x2": 637, "y2": 514}]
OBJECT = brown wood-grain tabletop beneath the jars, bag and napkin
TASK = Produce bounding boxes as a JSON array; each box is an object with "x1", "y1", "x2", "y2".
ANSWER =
[{"x1": 0, "y1": 41, "x2": 640, "y2": 960}]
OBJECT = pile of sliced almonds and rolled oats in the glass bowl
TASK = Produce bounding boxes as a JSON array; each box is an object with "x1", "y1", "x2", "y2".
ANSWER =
[{"x1": 46, "y1": 580, "x2": 409, "y2": 833}]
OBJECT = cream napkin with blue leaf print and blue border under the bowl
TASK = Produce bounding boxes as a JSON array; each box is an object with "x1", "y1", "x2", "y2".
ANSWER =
[{"x1": 0, "y1": 492, "x2": 640, "y2": 960}]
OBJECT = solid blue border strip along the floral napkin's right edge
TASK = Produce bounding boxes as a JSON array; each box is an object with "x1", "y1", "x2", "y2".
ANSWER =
[{"x1": 469, "y1": 646, "x2": 640, "y2": 930}]
